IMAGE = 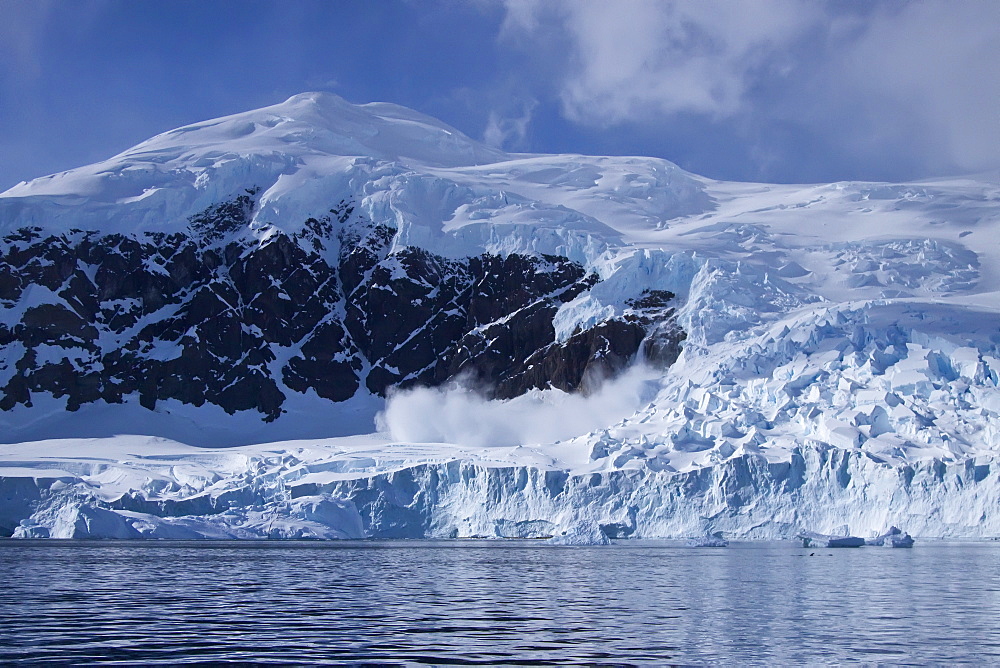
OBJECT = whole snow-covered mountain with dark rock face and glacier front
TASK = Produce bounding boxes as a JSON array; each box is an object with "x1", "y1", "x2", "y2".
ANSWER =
[{"x1": 0, "y1": 93, "x2": 1000, "y2": 542}]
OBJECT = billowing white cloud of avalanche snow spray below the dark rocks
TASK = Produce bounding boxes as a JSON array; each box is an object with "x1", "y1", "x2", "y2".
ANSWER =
[{"x1": 376, "y1": 364, "x2": 662, "y2": 447}]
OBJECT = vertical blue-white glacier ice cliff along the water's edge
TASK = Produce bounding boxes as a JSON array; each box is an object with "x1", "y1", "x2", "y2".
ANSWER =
[{"x1": 0, "y1": 442, "x2": 1000, "y2": 543}]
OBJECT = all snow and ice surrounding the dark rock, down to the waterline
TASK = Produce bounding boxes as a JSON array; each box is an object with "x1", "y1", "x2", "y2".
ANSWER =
[{"x1": 0, "y1": 93, "x2": 1000, "y2": 544}]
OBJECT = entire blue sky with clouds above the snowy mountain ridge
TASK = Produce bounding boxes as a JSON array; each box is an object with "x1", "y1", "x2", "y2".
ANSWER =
[{"x1": 0, "y1": 0, "x2": 1000, "y2": 190}]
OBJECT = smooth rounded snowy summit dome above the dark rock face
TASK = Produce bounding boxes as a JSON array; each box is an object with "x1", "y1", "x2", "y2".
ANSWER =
[{"x1": 2, "y1": 91, "x2": 509, "y2": 203}]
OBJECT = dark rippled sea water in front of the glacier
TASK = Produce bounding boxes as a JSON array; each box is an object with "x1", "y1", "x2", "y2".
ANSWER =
[{"x1": 0, "y1": 540, "x2": 1000, "y2": 665}]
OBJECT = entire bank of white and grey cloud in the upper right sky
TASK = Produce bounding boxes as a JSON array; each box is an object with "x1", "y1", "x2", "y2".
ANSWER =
[{"x1": 501, "y1": 0, "x2": 1000, "y2": 176}]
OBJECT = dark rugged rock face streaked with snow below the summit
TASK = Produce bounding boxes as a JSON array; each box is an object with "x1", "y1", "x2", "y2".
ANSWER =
[{"x1": 0, "y1": 190, "x2": 684, "y2": 421}]
